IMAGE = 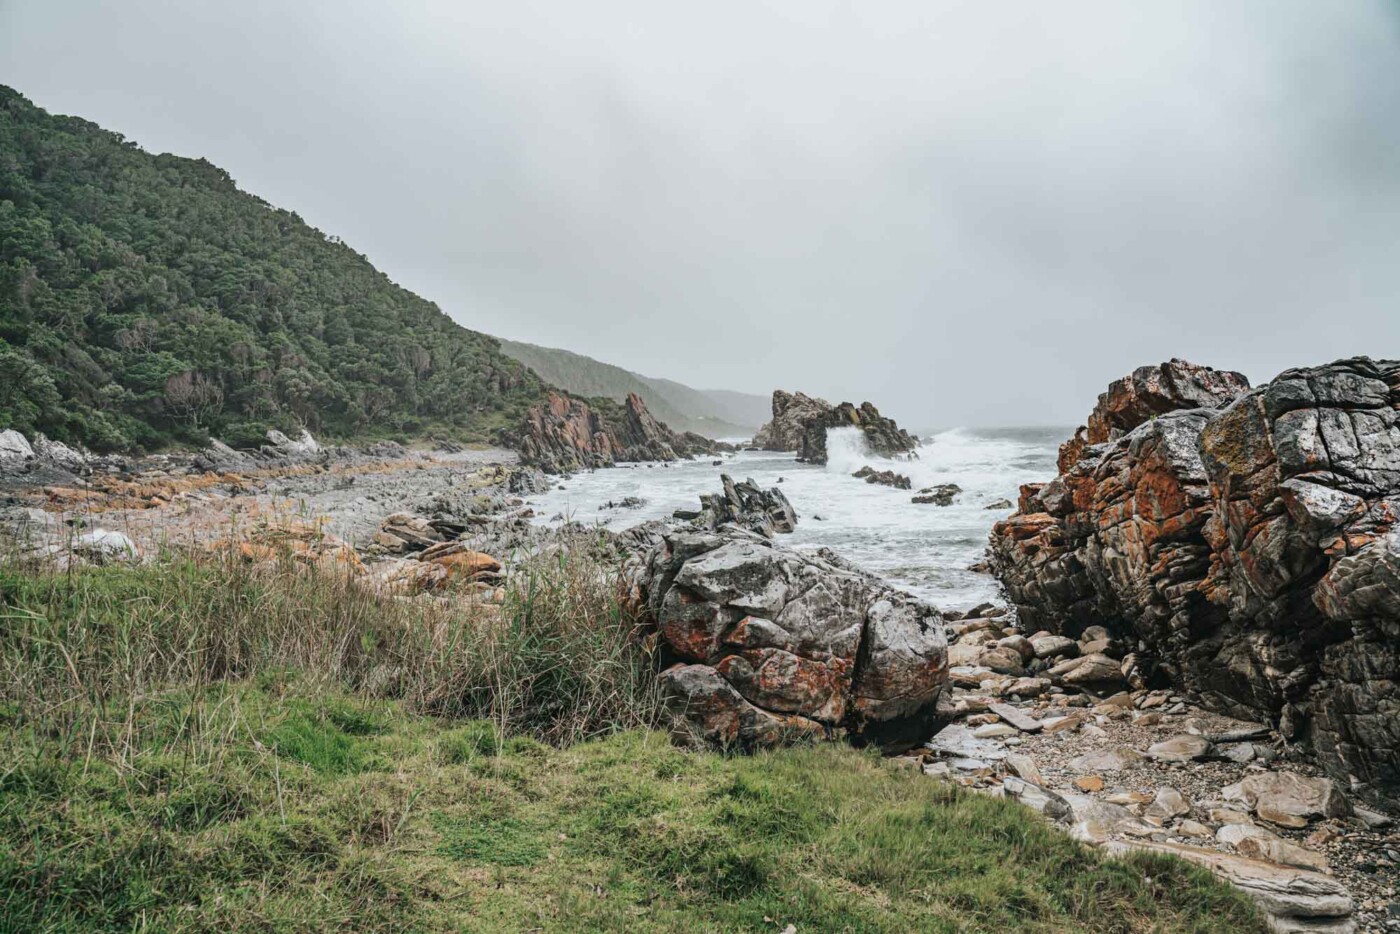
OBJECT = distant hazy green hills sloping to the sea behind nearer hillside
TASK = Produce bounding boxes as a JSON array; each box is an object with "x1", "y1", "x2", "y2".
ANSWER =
[{"x1": 501, "y1": 340, "x2": 770, "y2": 438}]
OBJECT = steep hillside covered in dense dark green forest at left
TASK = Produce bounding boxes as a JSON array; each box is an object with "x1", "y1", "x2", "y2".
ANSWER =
[{"x1": 0, "y1": 85, "x2": 543, "y2": 449}]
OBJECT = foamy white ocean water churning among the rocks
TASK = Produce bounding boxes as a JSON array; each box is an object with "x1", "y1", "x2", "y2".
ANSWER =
[{"x1": 531, "y1": 428, "x2": 1071, "y2": 609}]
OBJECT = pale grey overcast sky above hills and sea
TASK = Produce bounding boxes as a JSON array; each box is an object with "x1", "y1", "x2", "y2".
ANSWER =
[{"x1": 0, "y1": 0, "x2": 1400, "y2": 426}]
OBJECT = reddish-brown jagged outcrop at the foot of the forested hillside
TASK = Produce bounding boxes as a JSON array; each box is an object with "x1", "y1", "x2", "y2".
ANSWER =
[{"x1": 514, "y1": 392, "x2": 722, "y2": 473}]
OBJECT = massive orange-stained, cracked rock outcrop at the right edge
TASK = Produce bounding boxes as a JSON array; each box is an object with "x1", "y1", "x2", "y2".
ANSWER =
[{"x1": 991, "y1": 357, "x2": 1400, "y2": 784}]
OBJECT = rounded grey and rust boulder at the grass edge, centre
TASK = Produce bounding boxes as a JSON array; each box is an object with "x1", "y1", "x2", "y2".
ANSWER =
[{"x1": 641, "y1": 528, "x2": 948, "y2": 749}]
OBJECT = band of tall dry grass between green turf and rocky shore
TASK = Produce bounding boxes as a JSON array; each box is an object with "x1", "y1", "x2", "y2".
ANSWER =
[{"x1": 0, "y1": 555, "x2": 658, "y2": 753}]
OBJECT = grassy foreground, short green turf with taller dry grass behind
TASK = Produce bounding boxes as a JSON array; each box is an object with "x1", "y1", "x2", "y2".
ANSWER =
[{"x1": 0, "y1": 554, "x2": 1263, "y2": 934}]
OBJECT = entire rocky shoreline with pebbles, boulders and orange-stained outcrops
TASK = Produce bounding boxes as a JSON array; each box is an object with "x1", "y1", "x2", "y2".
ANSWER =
[{"x1": 0, "y1": 361, "x2": 1400, "y2": 931}]
